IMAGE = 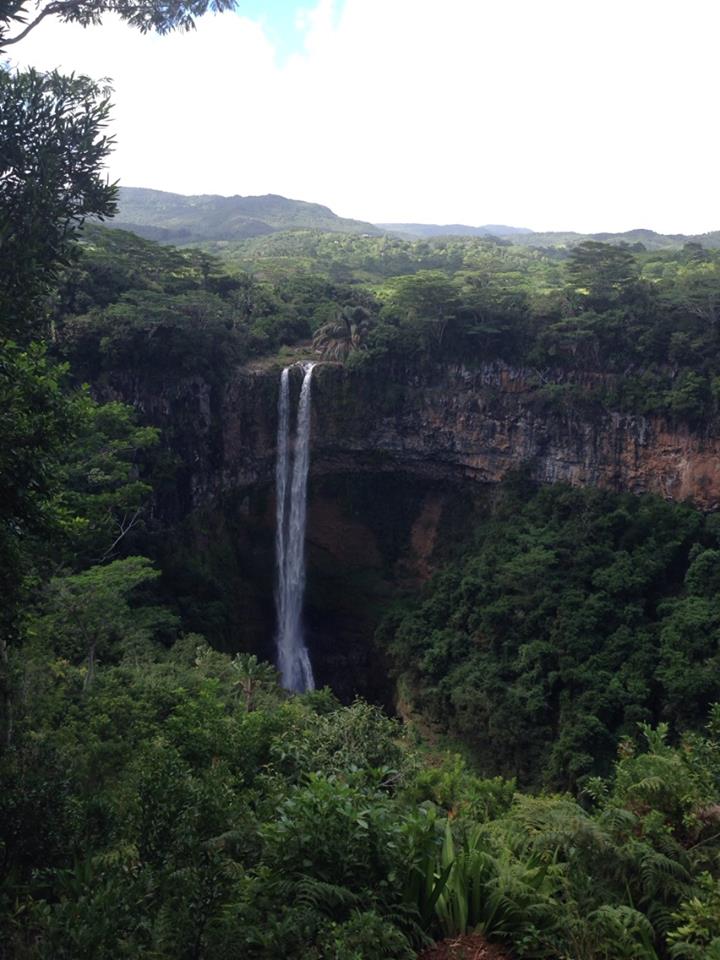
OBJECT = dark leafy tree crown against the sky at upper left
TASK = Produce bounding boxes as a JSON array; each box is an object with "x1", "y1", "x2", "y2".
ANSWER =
[{"x1": 0, "y1": 69, "x2": 116, "y2": 339}]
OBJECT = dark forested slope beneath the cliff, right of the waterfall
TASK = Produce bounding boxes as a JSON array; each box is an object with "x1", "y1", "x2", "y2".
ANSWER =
[{"x1": 381, "y1": 477, "x2": 720, "y2": 790}]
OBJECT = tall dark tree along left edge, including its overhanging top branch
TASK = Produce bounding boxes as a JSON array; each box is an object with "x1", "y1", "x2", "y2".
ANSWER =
[{"x1": 0, "y1": 0, "x2": 235, "y2": 743}]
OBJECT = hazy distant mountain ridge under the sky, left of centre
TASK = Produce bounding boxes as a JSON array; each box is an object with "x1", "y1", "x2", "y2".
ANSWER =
[{"x1": 112, "y1": 187, "x2": 383, "y2": 243}]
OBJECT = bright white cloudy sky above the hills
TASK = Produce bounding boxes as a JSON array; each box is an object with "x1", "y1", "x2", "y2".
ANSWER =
[{"x1": 9, "y1": 0, "x2": 720, "y2": 233}]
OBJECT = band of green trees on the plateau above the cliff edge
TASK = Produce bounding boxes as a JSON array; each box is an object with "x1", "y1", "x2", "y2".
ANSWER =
[{"x1": 52, "y1": 227, "x2": 720, "y2": 423}]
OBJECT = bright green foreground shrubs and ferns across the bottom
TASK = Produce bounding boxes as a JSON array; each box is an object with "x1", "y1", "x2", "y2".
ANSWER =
[{"x1": 0, "y1": 631, "x2": 720, "y2": 960}]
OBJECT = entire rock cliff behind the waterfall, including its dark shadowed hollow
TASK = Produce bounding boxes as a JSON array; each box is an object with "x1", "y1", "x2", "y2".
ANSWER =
[{"x1": 103, "y1": 363, "x2": 720, "y2": 703}]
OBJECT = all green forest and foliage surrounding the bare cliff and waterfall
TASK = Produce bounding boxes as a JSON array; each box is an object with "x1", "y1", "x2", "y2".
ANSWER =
[{"x1": 0, "y1": 0, "x2": 720, "y2": 960}]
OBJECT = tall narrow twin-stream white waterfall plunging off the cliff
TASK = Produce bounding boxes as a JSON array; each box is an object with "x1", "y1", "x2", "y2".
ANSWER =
[{"x1": 275, "y1": 363, "x2": 315, "y2": 693}]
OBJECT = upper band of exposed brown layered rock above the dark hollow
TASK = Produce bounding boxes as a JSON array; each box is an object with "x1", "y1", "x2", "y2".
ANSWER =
[{"x1": 211, "y1": 363, "x2": 720, "y2": 509}]
